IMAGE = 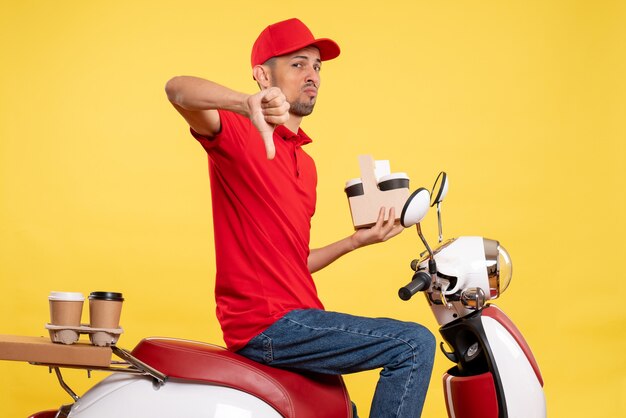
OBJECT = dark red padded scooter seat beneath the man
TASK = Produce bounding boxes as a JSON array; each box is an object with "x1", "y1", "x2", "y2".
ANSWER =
[{"x1": 132, "y1": 338, "x2": 352, "y2": 418}]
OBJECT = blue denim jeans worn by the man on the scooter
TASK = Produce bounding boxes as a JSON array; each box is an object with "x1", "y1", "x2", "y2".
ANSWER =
[{"x1": 238, "y1": 309, "x2": 435, "y2": 418}]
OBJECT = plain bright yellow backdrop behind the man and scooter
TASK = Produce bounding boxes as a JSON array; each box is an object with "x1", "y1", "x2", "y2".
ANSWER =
[{"x1": 0, "y1": 0, "x2": 626, "y2": 418}]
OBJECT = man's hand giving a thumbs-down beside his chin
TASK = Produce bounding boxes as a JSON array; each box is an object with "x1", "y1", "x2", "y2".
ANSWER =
[{"x1": 247, "y1": 87, "x2": 289, "y2": 160}]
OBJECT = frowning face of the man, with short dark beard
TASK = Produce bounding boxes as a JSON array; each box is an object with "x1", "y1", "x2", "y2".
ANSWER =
[{"x1": 269, "y1": 46, "x2": 322, "y2": 116}]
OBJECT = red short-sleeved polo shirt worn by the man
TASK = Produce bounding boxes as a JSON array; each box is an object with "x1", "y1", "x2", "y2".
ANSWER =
[{"x1": 192, "y1": 111, "x2": 323, "y2": 350}]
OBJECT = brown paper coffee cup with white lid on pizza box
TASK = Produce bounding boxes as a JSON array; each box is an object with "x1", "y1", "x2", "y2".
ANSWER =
[{"x1": 48, "y1": 292, "x2": 85, "y2": 344}]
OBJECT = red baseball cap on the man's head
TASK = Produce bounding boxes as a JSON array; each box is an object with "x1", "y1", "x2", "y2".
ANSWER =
[{"x1": 252, "y1": 19, "x2": 341, "y2": 67}]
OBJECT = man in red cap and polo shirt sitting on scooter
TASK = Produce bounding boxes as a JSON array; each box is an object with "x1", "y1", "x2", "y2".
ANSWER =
[{"x1": 166, "y1": 19, "x2": 435, "y2": 417}]
